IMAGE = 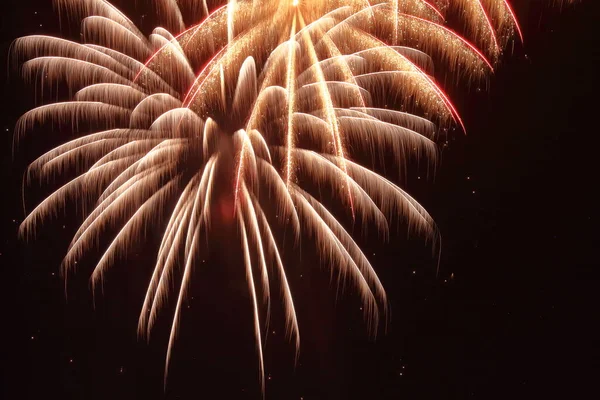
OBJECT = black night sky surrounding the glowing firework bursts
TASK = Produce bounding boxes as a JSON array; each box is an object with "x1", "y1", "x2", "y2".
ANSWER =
[{"x1": 0, "y1": 0, "x2": 600, "y2": 400}]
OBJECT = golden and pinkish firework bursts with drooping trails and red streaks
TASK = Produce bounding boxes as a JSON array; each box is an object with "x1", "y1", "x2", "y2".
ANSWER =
[{"x1": 14, "y1": 0, "x2": 576, "y2": 390}]
